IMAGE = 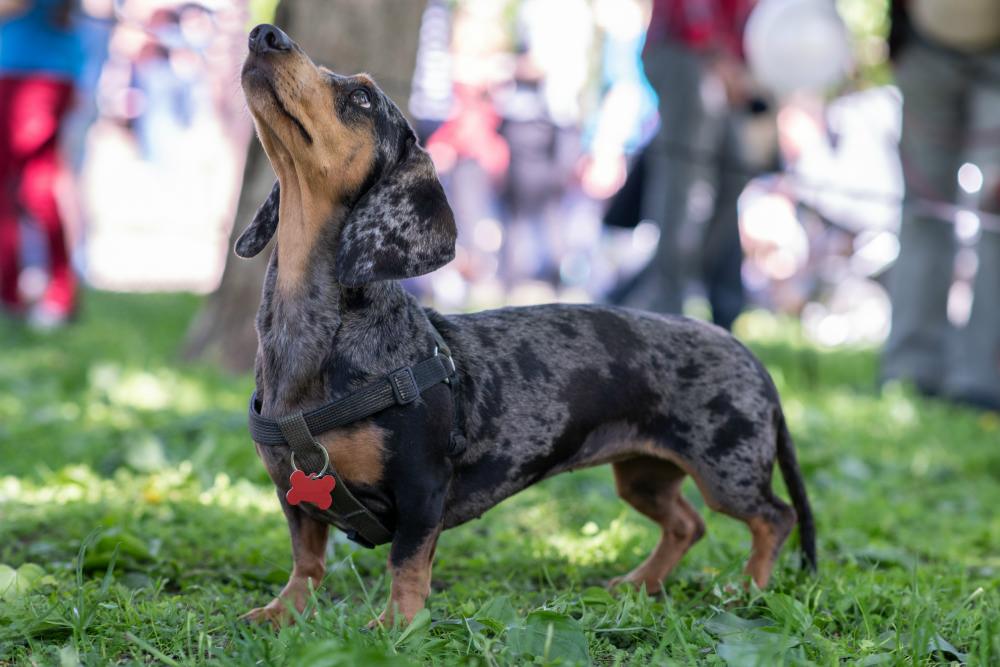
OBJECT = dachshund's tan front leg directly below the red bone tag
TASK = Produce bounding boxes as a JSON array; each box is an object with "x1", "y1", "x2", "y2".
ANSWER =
[{"x1": 243, "y1": 493, "x2": 329, "y2": 625}]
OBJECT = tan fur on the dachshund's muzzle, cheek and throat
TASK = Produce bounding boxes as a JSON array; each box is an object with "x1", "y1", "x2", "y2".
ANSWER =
[{"x1": 243, "y1": 51, "x2": 375, "y2": 293}]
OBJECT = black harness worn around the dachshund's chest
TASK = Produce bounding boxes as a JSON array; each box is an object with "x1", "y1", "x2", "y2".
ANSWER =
[{"x1": 249, "y1": 325, "x2": 465, "y2": 547}]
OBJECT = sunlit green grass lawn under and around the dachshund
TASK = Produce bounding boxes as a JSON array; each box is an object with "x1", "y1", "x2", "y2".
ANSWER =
[{"x1": 0, "y1": 294, "x2": 1000, "y2": 667}]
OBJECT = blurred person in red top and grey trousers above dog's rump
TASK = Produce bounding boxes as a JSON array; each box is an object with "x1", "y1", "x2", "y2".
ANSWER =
[{"x1": 619, "y1": 0, "x2": 754, "y2": 329}]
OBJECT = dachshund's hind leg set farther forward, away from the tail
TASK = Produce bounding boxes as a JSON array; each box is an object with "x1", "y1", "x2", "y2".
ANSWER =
[{"x1": 610, "y1": 456, "x2": 705, "y2": 593}]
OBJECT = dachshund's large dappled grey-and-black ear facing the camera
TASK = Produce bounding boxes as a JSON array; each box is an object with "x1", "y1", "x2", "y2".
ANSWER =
[{"x1": 337, "y1": 141, "x2": 457, "y2": 287}]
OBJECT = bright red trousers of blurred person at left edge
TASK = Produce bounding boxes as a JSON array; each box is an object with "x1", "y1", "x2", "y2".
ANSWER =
[{"x1": 0, "y1": 75, "x2": 76, "y2": 312}]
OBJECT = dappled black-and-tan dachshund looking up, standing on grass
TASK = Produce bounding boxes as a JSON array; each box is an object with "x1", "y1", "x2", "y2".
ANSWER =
[{"x1": 235, "y1": 24, "x2": 815, "y2": 623}]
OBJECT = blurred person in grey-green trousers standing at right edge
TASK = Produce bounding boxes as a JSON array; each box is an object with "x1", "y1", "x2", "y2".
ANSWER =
[{"x1": 882, "y1": 0, "x2": 1000, "y2": 410}]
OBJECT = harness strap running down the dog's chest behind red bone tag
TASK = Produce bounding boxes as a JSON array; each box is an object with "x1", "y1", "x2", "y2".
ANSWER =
[{"x1": 278, "y1": 412, "x2": 392, "y2": 547}]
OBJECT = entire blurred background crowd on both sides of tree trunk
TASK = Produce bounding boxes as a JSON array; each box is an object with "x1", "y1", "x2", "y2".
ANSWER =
[{"x1": 0, "y1": 0, "x2": 1000, "y2": 407}]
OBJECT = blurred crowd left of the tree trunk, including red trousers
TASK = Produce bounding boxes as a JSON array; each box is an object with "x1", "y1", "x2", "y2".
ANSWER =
[{"x1": 0, "y1": 0, "x2": 250, "y2": 312}]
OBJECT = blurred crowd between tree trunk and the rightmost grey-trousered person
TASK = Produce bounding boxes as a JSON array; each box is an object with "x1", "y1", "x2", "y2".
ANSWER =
[{"x1": 410, "y1": 0, "x2": 903, "y2": 344}]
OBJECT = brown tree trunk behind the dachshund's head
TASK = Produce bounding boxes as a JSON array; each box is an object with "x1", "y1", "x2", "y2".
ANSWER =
[{"x1": 182, "y1": 0, "x2": 424, "y2": 372}]
